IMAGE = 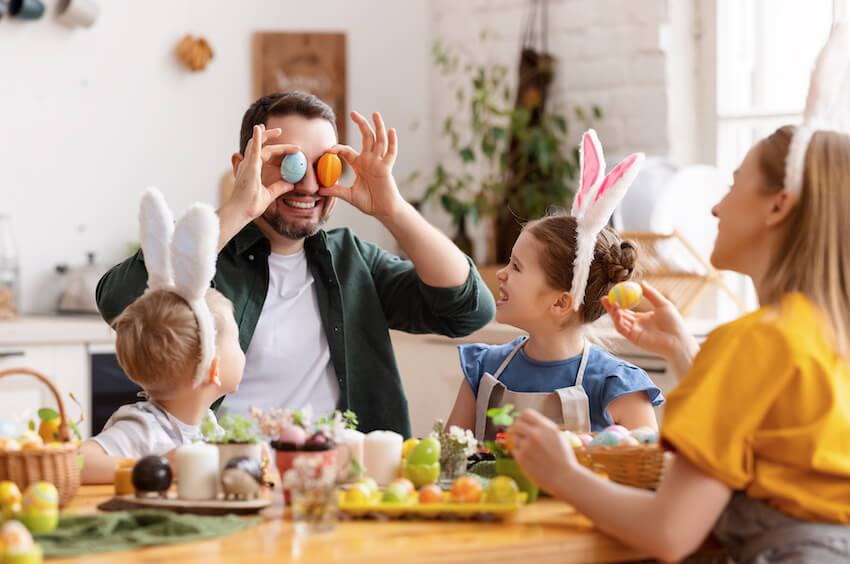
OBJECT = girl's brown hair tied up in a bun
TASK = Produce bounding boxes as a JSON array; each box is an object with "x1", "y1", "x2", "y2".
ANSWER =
[{"x1": 523, "y1": 213, "x2": 637, "y2": 323}]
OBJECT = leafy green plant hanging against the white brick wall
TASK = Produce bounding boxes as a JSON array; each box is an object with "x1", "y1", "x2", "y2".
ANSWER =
[{"x1": 420, "y1": 36, "x2": 602, "y2": 264}]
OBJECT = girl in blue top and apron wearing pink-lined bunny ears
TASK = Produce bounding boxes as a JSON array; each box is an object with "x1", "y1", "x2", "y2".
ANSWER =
[{"x1": 448, "y1": 130, "x2": 664, "y2": 440}]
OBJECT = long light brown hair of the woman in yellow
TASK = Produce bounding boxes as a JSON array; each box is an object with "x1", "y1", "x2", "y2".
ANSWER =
[{"x1": 758, "y1": 126, "x2": 850, "y2": 358}]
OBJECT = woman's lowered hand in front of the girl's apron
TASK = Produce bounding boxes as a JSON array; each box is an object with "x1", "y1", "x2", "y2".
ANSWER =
[{"x1": 509, "y1": 409, "x2": 579, "y2": 493}]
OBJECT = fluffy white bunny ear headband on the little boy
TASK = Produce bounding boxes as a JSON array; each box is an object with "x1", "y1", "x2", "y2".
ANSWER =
[{"x1": 139, "y1": 188, "x2": 219, "y2": 388}]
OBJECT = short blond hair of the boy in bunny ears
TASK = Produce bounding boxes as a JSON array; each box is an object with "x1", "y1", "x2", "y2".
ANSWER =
[{"x1": 112, "y1": 288, "x2": 230, "y2": 396}]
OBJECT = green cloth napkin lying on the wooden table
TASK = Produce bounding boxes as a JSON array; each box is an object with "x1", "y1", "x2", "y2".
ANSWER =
[{"x1": 35, "y1": 509, "x2": 262, "y2": 556}]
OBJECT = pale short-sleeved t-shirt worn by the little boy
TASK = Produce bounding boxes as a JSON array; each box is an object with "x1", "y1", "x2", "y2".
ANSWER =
[{"x1": 92, "y1": 400, "x2": 216, "y2": 458}]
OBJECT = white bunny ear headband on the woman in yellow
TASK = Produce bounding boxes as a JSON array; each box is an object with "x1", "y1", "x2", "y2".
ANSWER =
[{"x1": 785, "y1": 23, "x2": 850, "y2": 196}]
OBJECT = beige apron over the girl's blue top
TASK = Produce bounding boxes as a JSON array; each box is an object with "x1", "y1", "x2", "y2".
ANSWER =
[{"x1": 475, "y1": 337, "x2": 590, "y2": 441}]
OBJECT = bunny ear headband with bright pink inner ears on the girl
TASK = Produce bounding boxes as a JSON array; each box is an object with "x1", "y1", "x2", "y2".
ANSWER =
[{"x1": 570, "y1": 129, "x2": 643, "y2": 311}]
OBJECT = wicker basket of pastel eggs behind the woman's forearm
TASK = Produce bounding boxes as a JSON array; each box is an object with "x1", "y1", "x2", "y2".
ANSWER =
[{"x1": 576, "y1": 442, "x2": 670, "y2": 490}]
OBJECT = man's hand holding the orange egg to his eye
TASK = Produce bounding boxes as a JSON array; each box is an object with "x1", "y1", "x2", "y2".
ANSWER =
[{"x1": 319, "y1": 112, "x2": 404, "y2": 219}]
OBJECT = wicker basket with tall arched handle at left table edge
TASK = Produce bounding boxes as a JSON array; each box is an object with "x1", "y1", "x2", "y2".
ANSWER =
[{"x1": 0, "y1": 368, "x2": 80, "y2": 507}]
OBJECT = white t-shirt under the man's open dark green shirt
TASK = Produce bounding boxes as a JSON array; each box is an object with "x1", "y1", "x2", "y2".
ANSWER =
[{"x1": 223, "y1": 250, "x2": 340, "y2": 417}]
